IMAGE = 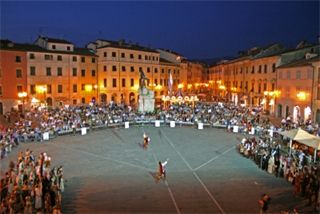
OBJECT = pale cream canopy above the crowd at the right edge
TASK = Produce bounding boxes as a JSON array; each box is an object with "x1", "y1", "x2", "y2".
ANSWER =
[{"x1": 279, "y1": 129, "x2": 320, "y2": 150}]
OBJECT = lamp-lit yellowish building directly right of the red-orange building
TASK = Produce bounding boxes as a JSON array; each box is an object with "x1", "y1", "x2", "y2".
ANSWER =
[{"x1": 26, "y1": 37, "x2": 98, "y2": 106}]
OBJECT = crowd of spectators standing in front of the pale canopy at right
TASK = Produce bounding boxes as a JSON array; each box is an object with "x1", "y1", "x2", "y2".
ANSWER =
[{"x1": 239, "y1": 135, "x2": 320, "y2": 211}]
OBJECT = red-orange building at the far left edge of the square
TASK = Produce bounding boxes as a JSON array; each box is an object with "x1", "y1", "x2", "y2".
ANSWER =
[{"x1": 0, "y1": 40, "x2": 28, "y2": 114}]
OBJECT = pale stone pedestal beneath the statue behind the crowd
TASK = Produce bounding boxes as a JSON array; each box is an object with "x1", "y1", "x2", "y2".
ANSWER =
[{"x1": 138, "y1": 88, "x2": 155, "y2": 113}]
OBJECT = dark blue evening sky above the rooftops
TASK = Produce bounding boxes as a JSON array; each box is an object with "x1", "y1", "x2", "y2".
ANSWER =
[{"x1": 0, "y1": 0, "x2": 320, "y2": 58}]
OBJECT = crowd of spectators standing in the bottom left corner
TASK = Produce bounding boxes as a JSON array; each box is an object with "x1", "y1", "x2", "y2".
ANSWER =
[{"x1": 0, "y1": 149, "x2": 64, "y2": 214}]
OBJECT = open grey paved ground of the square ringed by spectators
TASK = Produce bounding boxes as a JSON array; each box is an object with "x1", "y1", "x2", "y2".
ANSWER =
[{"x1": 1, "y1": 126, "x2": 316, "y2": 213}]
